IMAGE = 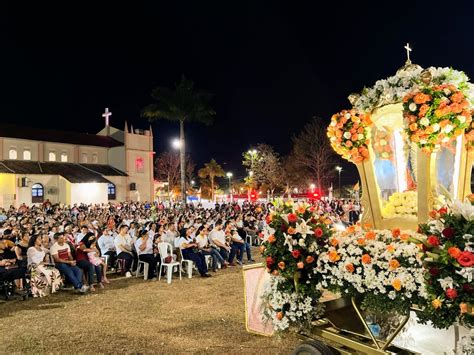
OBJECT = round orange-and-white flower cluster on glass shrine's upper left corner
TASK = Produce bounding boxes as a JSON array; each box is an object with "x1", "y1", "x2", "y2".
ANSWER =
[{"x1": 327, "y1": 110, "x2": 372, "y2": 164}]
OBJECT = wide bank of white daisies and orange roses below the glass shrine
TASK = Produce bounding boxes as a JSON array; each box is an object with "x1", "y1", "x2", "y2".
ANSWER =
[{"x1": 313, "y1": 226, "x2": 424, "y2": 314}]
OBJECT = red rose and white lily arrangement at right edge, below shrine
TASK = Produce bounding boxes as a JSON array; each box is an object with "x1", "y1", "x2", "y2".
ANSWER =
[{"x1": 419, "y1": 201, "x2": 474, "y2": 328}]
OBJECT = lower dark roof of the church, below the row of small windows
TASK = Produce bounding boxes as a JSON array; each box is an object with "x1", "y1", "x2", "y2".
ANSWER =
[{"x1": 0, "y1": 160, "x2": 127, "y2": 183}]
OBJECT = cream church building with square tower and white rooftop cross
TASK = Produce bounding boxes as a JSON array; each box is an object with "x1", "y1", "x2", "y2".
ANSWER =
[{"x1": 0, "y1": 109, "x2": 154, "y2": 208}]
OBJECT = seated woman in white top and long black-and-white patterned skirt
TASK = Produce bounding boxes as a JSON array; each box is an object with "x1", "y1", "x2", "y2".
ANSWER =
[{"x1": 26, "y1": 235, "x2": 62, "y2": 297}]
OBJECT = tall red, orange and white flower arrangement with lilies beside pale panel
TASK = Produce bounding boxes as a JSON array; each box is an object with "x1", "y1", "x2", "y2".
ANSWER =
[{"x1": 260, "y1": 201, "x2": 331, "y2": 331}]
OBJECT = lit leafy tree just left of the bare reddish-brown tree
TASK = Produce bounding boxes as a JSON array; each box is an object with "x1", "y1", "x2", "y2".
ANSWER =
[{"x1": 242, "y1": 144, "x2": 284, "y2": 197}]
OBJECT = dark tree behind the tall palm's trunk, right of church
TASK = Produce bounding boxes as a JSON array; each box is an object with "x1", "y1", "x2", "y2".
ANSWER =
[{"x1": 155, "y1": 151, "x2": 196, "y2": 199}]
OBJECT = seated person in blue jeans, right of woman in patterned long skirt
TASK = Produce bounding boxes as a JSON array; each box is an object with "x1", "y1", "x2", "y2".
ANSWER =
[{"x1": 51, "y1": 232, "x2": 89, "y2": 293}]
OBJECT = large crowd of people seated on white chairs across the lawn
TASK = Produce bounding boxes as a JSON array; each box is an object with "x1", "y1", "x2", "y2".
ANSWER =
[{"x1": 0, "y1": 200, "x2": 360, "y2": 297}]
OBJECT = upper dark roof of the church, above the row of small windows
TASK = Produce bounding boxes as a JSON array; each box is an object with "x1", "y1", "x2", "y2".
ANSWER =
[{"x1": 0, "y1": 123, "x2": 123, "y2": 148}]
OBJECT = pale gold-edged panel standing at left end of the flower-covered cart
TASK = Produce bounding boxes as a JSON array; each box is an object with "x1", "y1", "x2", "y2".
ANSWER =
[{"x1": 243, "y1": 264, "x2": 273, "y2": 336}]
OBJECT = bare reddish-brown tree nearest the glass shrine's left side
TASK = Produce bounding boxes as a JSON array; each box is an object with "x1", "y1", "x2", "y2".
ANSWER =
[{"x1": 289, "y1": 117, "x2": 337, "y2": 195}]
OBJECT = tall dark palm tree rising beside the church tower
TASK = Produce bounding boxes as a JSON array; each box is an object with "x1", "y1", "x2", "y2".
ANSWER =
[{"x1": 142, "y1": 75, "x2": 216, "y2": 203}]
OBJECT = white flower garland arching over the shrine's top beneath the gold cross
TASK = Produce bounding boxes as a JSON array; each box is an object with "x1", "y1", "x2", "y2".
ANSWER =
[{"x1": 353, "y1": 67, "x2": 474, "y2": 112}]
